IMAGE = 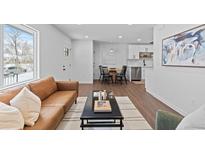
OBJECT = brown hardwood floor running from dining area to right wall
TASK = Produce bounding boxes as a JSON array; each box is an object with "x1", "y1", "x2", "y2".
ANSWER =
[{"x1": 79, "y1": 81, "x2": 181, "y2": 128}]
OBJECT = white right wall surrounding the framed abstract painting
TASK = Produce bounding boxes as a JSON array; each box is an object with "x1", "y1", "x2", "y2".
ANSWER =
[{"x1": 145, "y1": 25, "x2": 205, "y2": 115}]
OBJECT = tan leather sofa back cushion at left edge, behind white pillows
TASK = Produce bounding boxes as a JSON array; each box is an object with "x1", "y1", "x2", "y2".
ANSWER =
[{"x1": 0, "y1": 85, "x2": 29, "y2": 105}]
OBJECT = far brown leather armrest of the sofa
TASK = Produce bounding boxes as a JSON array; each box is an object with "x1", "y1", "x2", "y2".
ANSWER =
[{"x1": 56, "y1": 81, "x2": 79, "y2": 94}]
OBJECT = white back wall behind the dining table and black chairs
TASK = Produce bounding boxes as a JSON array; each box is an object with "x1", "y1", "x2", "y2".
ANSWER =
[{"x1": 93, "y1": 41, "x2": 128, "y2": 79}]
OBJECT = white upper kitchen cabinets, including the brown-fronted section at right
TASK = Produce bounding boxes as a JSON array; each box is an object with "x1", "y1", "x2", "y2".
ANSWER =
[{"x1": 128, "y1": 45, "x2": 153, "y2": 59}]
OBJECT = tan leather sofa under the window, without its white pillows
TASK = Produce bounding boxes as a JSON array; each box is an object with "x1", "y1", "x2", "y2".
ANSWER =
[{"x1": 0, "y1": 77, "x2": 79, "y2": 130}]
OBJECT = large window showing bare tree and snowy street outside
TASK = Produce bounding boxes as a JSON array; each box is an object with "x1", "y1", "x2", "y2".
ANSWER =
[{"x1": 0, "y1": 25, "x2": 39, "y2": 88}]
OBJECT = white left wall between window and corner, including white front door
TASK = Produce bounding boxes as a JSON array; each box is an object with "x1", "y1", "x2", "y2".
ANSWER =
[{"x1": 29, "y1": 24, "x2": 72, "y2": 80}]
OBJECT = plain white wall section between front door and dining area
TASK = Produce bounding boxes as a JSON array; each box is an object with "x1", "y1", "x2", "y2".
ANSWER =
[{"x1": 72, "y1": 40, "x2": 93, "y2": 83}]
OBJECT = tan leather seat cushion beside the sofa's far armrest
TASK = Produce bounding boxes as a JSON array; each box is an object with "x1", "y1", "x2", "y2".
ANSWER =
[{"x1": 42, "y1": 91, "x2": 77, "y2": 112}]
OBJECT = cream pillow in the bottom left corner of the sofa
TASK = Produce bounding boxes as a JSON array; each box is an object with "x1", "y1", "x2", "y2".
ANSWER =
[{"x1": 0, "y1": 102, "x2": 24, "y2": 130}]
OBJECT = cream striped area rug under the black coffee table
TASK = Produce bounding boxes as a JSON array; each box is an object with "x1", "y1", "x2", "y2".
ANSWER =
[{"x1": 57, "y1": 97, "x2": 152, "y2": 130}]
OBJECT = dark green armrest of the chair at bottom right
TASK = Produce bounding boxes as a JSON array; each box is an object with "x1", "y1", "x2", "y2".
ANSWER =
[{"x1": 155, "y1": 110, "x2": 183, "y2": 130}]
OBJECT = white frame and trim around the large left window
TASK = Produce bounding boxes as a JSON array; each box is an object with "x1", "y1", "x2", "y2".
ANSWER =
[{"x1": 0, "y1": 24, "x2": 40, "y2": 90}]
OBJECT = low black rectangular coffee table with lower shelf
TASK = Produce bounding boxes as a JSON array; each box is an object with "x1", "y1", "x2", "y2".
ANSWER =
[{"x1": 80, "y1": 91, "x2": 124, "y2": 130}]
